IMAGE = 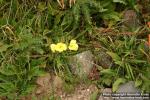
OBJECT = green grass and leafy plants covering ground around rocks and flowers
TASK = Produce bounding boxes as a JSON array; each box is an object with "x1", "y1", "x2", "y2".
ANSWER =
[{"x1": 0, "y1": 0, "x2": 150, "y2": 100}]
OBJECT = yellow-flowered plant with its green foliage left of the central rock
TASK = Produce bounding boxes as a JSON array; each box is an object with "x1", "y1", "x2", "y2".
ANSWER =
[{"x1": 49, "y1": 40, "x2": 78, "y2": 74}]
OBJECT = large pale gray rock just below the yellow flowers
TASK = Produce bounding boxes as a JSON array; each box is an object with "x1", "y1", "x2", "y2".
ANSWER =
[{"x1": 69, "y1": 51, "x2": 94, "y2": 78}]
